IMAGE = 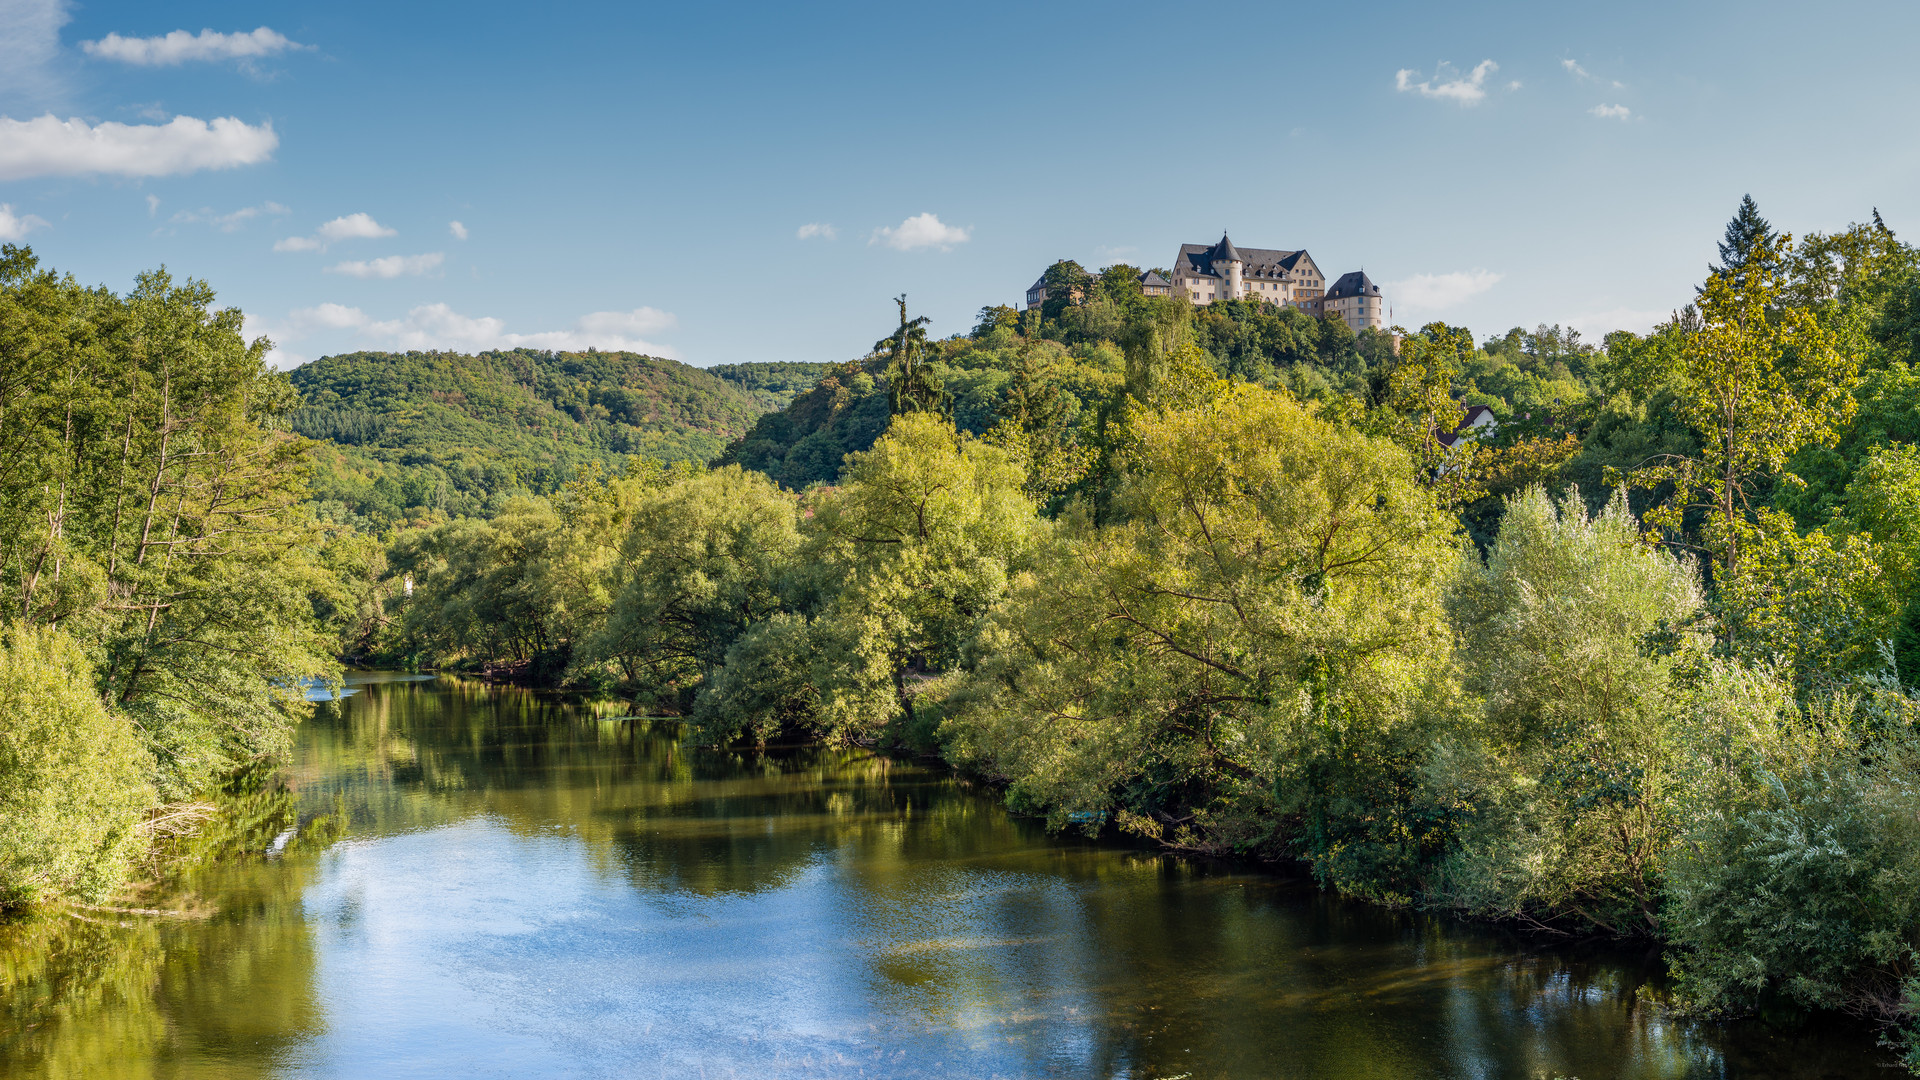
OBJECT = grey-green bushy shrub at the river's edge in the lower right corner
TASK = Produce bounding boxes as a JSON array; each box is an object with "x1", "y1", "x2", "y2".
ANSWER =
[{"x1": 1668, "y1": 678, "x2": 1920, "y2": 1049}]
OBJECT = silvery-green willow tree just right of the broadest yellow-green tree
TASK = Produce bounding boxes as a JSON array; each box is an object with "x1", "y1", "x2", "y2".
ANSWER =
[{"x1": 1438, "y1": 488, "x2": 1701, "y2": 934}]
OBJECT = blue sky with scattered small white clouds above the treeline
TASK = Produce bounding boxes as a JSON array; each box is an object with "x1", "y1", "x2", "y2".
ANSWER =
[{"x1": 0, "y1": 0, "x2": 1920, "y2": 365}]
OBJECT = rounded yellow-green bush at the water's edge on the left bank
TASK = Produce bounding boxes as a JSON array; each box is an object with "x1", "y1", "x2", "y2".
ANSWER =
[{"x1": 0, "y1": 626, "x2": 154, "y2": 907}]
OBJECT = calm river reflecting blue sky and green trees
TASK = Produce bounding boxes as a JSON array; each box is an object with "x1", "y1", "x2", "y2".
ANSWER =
[{"x1": 0, "y1": 676, "x2": 1891, "y2": 1080}]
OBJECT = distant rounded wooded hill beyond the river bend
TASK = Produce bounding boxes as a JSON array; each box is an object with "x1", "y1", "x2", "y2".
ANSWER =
[{"x1": 290, "y1": 350, "x2": 826, "y2": 527}]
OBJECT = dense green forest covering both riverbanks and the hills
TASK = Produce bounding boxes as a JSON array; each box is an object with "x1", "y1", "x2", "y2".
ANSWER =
[{"x1": 11, "y1": 191, "x2": 1920, "y2": 1068}]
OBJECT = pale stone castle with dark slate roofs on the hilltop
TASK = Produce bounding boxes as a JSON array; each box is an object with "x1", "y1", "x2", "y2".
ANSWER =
[{"x1": 1027, "y1": 233, "x2": 1386, "y2": 332}]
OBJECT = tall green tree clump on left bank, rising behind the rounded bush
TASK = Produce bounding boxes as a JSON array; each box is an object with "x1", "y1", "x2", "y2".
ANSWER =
[{"x1": 0, "y1": 246, "x2": 334, "y2": 799}]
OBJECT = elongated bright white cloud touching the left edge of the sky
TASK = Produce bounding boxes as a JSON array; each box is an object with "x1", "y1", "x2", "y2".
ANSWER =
[{"x1": 0, "y1": 113, "x2": 280, "y2": 181}]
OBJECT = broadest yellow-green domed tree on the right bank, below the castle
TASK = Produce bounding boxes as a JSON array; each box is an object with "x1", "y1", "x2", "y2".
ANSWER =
[{"x1": 943, "y1": 388, "x2": 1452, "y2": 894}]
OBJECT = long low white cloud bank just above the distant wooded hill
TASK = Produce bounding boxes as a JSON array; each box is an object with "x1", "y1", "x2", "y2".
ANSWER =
[{"x1": 288, "y1": 304, "x2": 674, "y2": 357}]
